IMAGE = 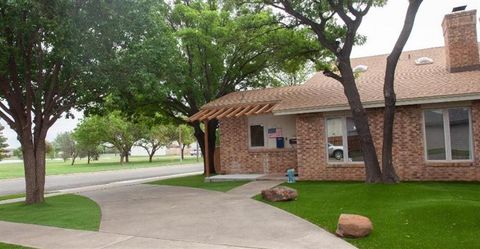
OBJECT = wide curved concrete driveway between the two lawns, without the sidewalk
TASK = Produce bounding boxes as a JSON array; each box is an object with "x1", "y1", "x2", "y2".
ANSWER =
[{"x1": 81, "y1": 185, "x2": 354, "y2": 249}]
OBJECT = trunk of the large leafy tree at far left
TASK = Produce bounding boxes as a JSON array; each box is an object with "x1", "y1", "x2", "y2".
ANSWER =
[{"x1": 21, "y1": 132, "x2": 45, "y2": 204}]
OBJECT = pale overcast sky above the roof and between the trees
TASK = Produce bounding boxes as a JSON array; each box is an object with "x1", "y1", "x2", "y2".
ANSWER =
[{"x1": 0, "y1": 0, "x2": 480, "y2": 148}]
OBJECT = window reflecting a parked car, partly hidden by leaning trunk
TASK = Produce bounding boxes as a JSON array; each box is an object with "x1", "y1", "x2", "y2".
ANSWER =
[{"x1": 327, "y1": 117, "x2": 363, "y2": 163}]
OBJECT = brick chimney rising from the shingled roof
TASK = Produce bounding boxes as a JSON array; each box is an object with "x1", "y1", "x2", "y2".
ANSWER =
[{"x1": 442, "y1": 10, "x2": 480, "y2": 73}]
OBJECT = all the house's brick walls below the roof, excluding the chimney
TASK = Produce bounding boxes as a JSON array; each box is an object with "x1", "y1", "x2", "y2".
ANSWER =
[{"x1": 220, "y1": 101, "x2": 480, "y2": 181}]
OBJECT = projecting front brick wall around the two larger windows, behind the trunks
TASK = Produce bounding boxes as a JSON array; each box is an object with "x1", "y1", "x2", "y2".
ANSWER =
[{"x1": 297, "y1": 101, "x2": 480, "y2": 181}]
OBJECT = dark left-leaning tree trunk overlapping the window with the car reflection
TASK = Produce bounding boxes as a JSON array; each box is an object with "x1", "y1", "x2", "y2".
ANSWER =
[{"x1": 339, "y1": 59, "x2": 382, "y2": 183}]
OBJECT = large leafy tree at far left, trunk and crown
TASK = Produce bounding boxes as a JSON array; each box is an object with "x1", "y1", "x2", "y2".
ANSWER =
[{"x1": 0, "y1": 0, "x2": 150, "y2": 204}]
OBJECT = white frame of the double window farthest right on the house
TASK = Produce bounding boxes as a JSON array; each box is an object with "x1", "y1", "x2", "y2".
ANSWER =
[{"x1": 422, "y1": 106, "x2": 475, "y2": 163}]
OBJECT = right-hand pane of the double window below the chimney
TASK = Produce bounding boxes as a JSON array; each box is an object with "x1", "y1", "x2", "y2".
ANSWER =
[{"x1": 448, "y1": 108, "x2": 471, "y2": 160}]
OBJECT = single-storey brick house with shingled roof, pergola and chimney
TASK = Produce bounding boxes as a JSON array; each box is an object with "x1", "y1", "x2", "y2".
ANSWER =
[{"x1": 190, "y1": 10, "x2": 480, "y2": 181}]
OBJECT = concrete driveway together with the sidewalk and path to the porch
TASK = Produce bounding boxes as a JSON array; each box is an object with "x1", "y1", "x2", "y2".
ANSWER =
[{"x1": 0, "y1": 181, "x2": 355, "y2": 249}]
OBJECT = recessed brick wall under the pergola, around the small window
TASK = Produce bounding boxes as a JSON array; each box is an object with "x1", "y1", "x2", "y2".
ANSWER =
[{"x1": 220, "y1": 117, "x2": 297, "y2": 174}]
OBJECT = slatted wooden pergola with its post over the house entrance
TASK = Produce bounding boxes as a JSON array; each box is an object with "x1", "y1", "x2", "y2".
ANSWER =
[{"x1": 188, "y1": 103, "x2": 276, "y2": 176}]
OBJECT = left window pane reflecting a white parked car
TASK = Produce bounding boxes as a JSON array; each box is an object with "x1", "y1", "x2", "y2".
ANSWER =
[{"x1": 327, "y1": 118, "x2": 343, "y2": 162}]
